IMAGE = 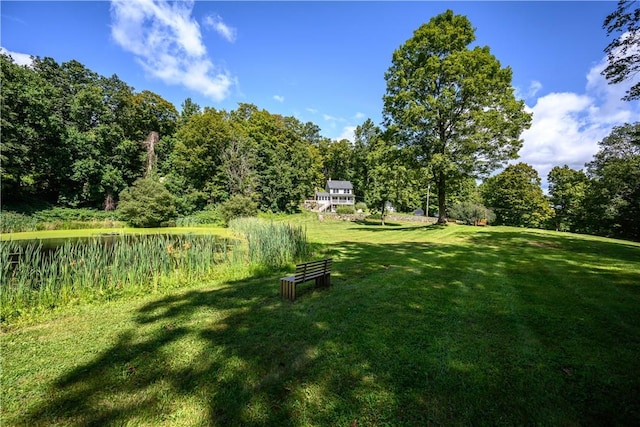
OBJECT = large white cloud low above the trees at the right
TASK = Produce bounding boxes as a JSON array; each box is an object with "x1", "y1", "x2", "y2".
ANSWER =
[{"x1": 516, "y1": 55, "x2": 640, "y2": 188}]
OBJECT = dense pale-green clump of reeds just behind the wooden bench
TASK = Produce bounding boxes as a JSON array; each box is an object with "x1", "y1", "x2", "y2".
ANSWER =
[{"x1": 229, "y1": 218, "x2": 310, "y2": 268}]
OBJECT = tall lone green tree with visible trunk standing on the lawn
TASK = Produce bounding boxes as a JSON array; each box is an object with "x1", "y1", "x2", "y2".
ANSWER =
[{"x1": 383, "y1": 10, "x2": 531, "y2": 222}]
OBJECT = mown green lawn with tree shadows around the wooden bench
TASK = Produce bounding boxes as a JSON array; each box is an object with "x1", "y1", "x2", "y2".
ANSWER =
[{"x1": 0, "y1": 217, "x2": 640, "y2": 426}]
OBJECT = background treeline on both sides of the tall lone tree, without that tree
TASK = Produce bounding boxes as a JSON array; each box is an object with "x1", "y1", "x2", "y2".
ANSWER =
[{"x1": 0, "y1": 55, "x2": 640, "y2": 240}]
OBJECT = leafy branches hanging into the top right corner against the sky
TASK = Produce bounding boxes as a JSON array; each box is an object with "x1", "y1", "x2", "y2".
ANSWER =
[{"x1": 602, "y1": 0, "x2": 640, "y2": 101}]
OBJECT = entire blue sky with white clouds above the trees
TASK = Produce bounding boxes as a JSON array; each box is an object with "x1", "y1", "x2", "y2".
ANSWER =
[{"x1": 0, "y1": 0, "x2": 640, "y2": 187}]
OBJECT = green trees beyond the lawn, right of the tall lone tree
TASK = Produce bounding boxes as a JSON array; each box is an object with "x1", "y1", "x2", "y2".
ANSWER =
[{"x1": 466, "y1": 122, "x2": 640, "y2": 240}]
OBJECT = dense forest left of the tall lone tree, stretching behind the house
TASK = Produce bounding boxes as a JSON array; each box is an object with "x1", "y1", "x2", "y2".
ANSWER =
[{"x1": 0, "y1": 55, "x2": 440, "y2": 216}]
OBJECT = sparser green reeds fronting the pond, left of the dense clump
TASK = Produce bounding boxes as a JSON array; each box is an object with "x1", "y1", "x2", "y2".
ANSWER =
[{"x1": 0, "y1": 235, "x2": 238, "y2": 321}]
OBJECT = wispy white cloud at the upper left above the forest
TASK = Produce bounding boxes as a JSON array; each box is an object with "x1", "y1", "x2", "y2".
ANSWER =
[{"x1": 111, "y1": 0, "x2": 236, "y2": 101}]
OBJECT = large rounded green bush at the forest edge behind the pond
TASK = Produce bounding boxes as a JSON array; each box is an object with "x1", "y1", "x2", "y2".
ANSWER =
[{"x1": 118, "y1": 178, "x2": 177, "y2": 227}]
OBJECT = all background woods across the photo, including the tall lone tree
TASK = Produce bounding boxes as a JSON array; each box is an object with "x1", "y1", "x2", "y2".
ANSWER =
[{"x1": 0, "y1": 11, "x2": 640, "y2": 240}]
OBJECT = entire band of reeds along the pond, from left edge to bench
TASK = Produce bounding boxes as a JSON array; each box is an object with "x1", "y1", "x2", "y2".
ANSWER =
[{"x1": 0, "y1": 218, "x2": 308, "y2": 322}]
